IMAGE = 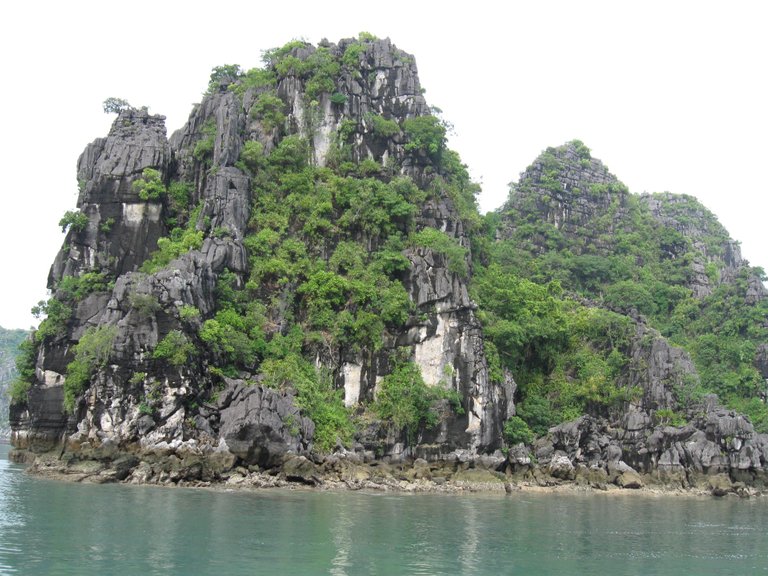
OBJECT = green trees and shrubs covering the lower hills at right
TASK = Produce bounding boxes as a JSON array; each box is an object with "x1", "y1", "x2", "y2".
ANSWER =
[{"x1": 486, "y1": 141, "x2": 768, "y2": 436}]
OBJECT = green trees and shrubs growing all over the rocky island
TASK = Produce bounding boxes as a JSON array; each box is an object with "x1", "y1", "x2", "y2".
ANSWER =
[{"x1": 36, "y1": 45, "x2": 768, "y2": 460}]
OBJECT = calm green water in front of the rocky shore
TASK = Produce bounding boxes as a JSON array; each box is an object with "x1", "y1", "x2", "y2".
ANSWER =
[{"x1": 0, "y1": 446, "x2": 768, "y2": 576}]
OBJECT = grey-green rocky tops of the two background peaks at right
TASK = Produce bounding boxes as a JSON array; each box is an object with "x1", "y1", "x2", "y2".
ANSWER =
[{"x1": 497, "y1": 141, "x2": 768, "y2": 303}]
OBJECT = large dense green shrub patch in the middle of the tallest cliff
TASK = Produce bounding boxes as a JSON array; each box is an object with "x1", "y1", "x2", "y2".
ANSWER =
[{"x1": 237, "y1": 142, "x2": 424, "y2": 362}]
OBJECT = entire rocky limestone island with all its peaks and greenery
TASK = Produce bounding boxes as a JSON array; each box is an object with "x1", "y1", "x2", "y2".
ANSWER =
[{"x1": 10, "y1": 42, "x2": 768, "y2": 493}]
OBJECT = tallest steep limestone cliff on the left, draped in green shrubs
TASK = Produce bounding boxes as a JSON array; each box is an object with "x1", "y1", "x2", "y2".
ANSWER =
[{"x1": 11, "y1": 37, "x2": 512, "y2": 481}]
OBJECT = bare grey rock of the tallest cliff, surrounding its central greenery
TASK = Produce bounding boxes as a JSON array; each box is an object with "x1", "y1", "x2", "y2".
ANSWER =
[{"x1": 11, "y1": 40, "x2": 511, "y2": 476}]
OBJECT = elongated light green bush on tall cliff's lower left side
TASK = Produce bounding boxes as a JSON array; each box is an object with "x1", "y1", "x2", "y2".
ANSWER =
[{"x1": 64, "y1": 325, "x2": 117, "y2": 412}]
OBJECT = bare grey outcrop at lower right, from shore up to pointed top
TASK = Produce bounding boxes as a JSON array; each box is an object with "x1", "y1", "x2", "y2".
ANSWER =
[{"x1": 520, "y1": 308, "x2": 768, "y2": 488}]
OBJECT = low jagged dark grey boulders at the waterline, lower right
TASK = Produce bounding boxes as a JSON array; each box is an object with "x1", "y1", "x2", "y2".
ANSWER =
[{"x1": 532, "y1": 397, "x2": 768, "y2": 495}]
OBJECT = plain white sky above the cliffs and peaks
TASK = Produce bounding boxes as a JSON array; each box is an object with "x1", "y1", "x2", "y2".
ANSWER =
[{"x1": 0, "y1": 0, "x2": 768, "y2": 328}]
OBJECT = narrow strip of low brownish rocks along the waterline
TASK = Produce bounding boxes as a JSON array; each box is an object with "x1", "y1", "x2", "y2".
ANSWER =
[{"x1": 9, "y1": 450, "x2": 768, "y2": 498}]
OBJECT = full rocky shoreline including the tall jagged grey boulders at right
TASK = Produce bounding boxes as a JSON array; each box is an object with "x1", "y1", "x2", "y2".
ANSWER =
[{"x1": 9, "y1": 386, "x2": 768, "y2": 498}]
